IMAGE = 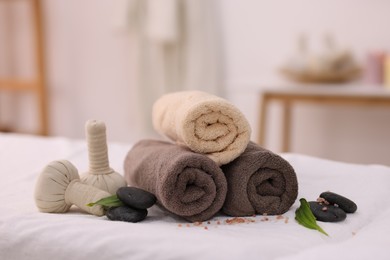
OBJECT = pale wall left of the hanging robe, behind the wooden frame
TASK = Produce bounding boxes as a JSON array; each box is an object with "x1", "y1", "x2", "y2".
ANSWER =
[{"x1": 0, "y1": 0, "x2": 142, "y2": 141}]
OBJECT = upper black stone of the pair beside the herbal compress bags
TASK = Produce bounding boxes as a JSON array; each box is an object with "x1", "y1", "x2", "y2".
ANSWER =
[{"x1": 116, "y1": 187, "x2": 157, "y2": 209}]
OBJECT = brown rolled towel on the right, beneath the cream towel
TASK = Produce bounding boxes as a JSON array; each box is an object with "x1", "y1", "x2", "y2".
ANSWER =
[{"x1": 222, "y1": 142, "x2": 298, "y2": 217}]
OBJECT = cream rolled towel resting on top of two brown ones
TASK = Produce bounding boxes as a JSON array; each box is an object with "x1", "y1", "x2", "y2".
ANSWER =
[{"x1": 153, "y1": 91, "x2": 251, "y2": 165}]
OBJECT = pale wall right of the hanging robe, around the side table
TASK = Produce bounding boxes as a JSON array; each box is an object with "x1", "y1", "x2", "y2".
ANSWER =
[{"x1": 220, "y1": 0, "x2": 390, "y2": 164}]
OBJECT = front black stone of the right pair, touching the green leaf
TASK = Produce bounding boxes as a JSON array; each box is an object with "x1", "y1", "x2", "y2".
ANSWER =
[{"x1": 309, "y1": 201, "x2": 347, "y2": 222}]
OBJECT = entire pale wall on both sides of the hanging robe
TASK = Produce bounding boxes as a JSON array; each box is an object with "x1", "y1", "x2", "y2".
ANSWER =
[{"x1": 0, "y1": 0, "x2": 390, "y2": 165}]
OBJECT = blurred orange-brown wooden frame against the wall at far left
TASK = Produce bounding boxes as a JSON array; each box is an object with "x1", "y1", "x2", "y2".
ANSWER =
[{"x1": 0, "y1": 0, "x2": 48, "y2": 135}]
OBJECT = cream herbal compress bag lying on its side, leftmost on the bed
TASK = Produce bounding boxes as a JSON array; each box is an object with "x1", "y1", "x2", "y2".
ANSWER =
[{"x1": 34, "y1": 160, "x2": 111, "y2": 216}]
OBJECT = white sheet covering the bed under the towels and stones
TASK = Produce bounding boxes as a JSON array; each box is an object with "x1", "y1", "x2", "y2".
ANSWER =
[{"x1": 0, "y1": 134, "x2": 390, "y2": 260}]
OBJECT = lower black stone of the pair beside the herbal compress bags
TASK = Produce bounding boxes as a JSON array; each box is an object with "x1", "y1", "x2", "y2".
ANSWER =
[{"x1": 106, "y1": 206, "x2": 148, "y2": 223}]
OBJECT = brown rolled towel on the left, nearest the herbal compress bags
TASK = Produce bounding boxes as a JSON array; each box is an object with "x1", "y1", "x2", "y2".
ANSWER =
[{"x1": 124, "y1": 140, "x2": 227, "y2": 222}]
